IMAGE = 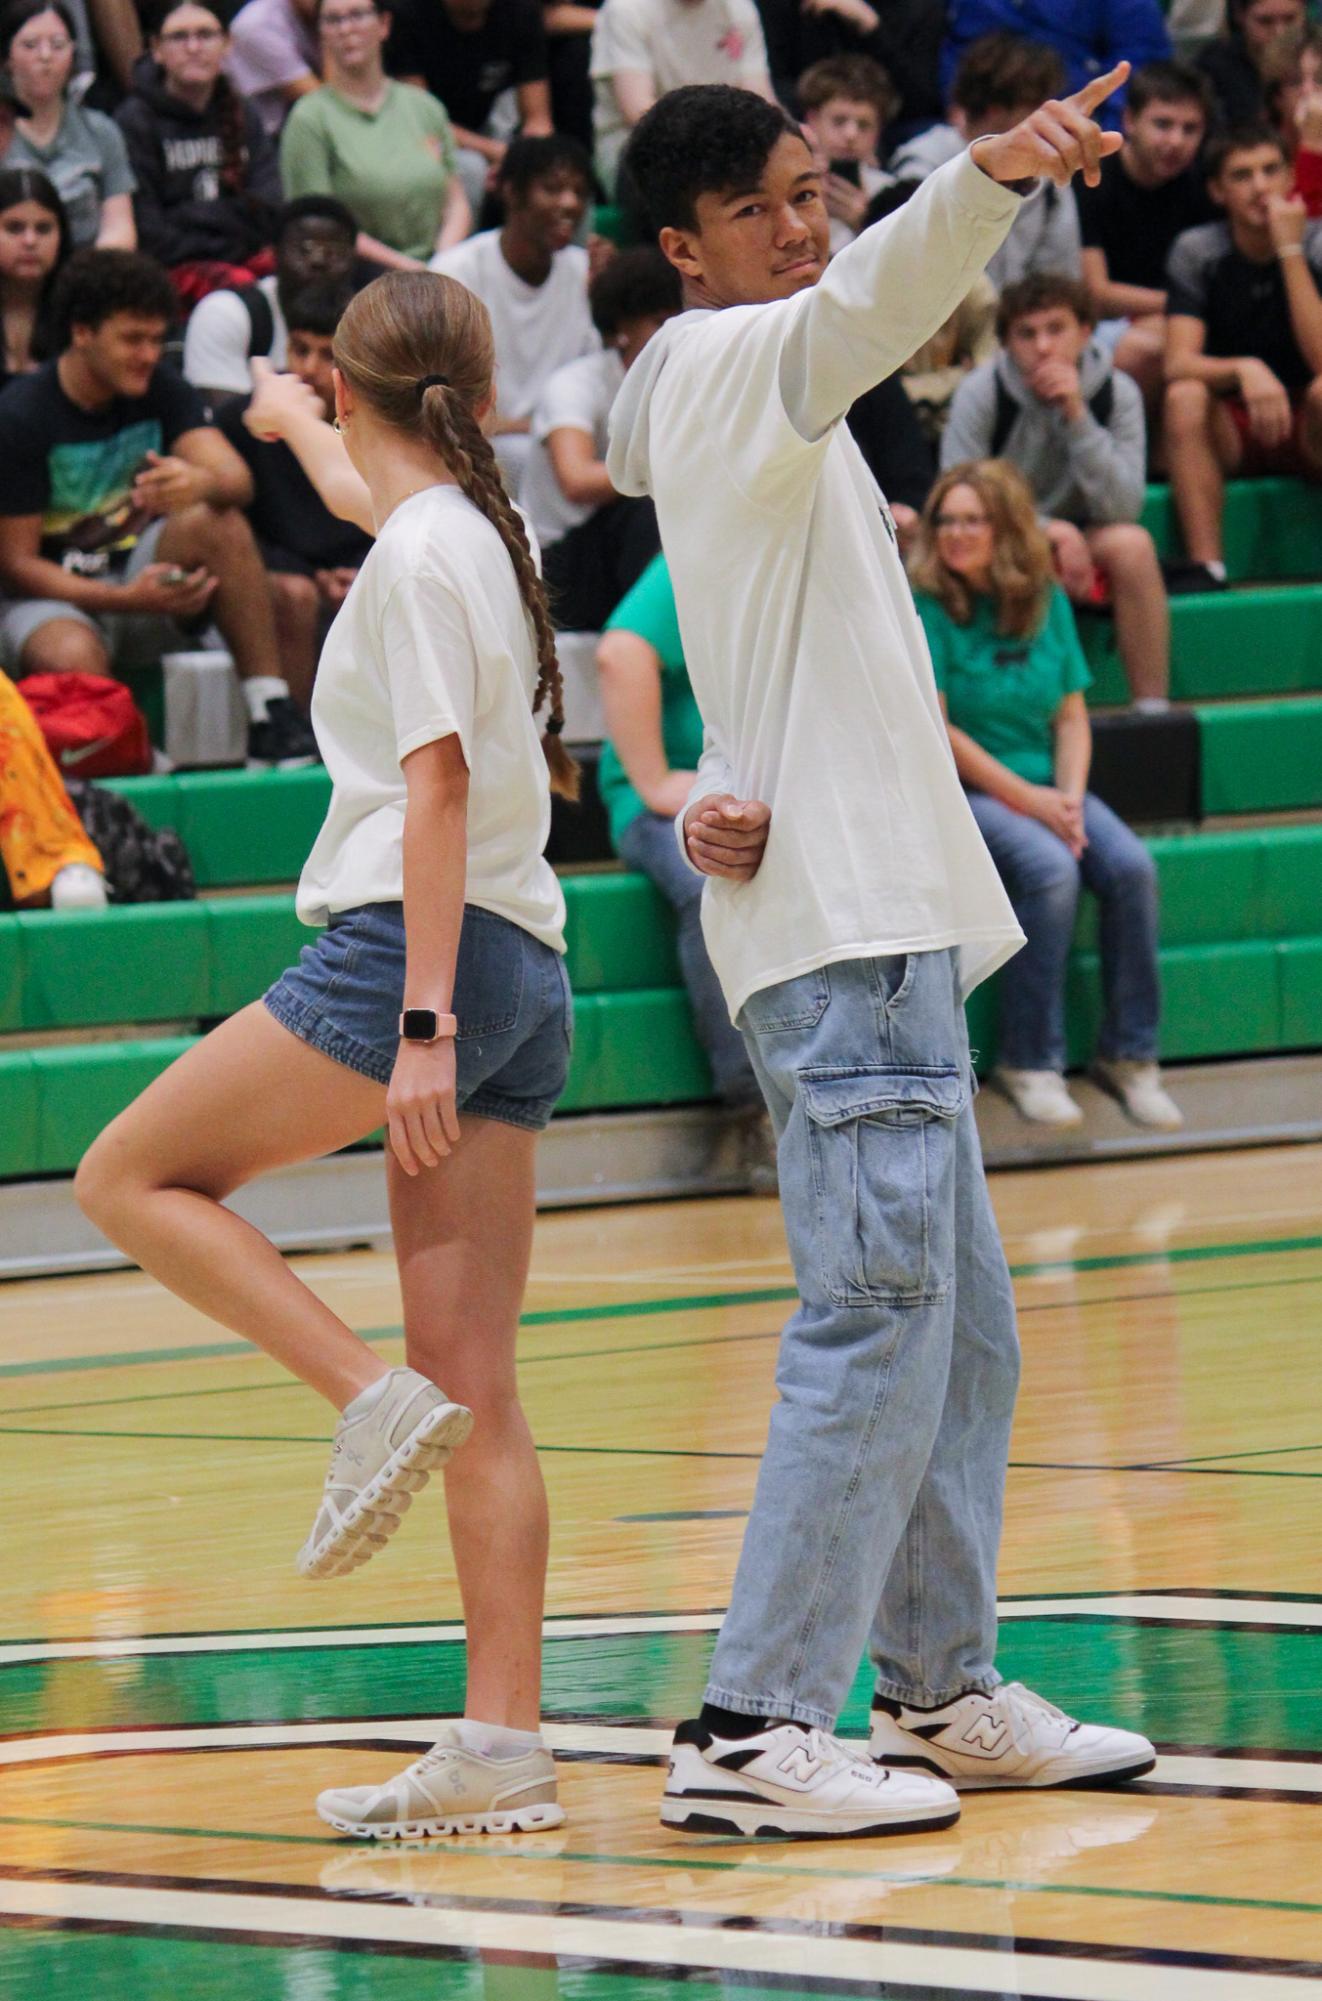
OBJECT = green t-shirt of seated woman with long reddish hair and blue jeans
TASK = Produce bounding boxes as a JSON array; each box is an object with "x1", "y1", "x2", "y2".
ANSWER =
[{"x1": 914, "y1": 584, "x2": 1092, "y2": 784}]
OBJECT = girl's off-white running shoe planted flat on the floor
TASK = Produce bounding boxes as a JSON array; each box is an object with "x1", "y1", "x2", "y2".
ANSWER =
[{"x1": 316, "y1": 1729, "x2": 564, "y2": 1841}]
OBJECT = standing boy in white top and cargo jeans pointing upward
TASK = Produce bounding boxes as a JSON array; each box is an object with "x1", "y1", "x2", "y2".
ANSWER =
[{"x1": 606, "y1": 64, "x2": 1154, "y2": 1835}]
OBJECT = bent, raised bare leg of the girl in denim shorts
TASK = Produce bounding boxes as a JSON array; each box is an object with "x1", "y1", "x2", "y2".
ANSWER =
[{"x1": 74, "y1": 1001, "x2": 386, "y2": 1411}]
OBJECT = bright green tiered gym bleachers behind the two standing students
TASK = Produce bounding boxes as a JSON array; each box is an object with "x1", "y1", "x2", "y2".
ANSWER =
[{"x1": 0, "y1": 480, "x2": 1322, "y2": 1181}]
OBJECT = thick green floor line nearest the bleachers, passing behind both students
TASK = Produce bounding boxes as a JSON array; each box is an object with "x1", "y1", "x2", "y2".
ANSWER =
[{"x1": 0, "y1": 1237, "x2": 1322, "y2": 1379}]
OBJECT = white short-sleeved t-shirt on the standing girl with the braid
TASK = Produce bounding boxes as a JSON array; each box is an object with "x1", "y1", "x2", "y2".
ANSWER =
[{"x1": 298, "y1": 486, "x2": 564, "y2": 952}]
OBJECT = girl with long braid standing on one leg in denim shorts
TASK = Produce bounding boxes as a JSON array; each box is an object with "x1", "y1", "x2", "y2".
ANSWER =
[{"x1": 76, "y1": 272, "x2": 576, "y2": 1837}]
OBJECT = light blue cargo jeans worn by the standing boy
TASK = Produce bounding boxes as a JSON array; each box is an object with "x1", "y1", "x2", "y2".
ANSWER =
[{"x1": 706, "y1": 952, "x2": 1018, "y2": 1729}]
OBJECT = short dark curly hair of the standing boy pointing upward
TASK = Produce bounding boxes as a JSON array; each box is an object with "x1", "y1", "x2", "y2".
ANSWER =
[{"x1": 622, "y1": 84, "x2": 800, "y2": 234}]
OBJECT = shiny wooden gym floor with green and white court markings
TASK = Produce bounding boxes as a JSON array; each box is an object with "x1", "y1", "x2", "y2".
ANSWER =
[{"x1": 0, "y1": 1147, "x2": 1322, "y2": 2001}]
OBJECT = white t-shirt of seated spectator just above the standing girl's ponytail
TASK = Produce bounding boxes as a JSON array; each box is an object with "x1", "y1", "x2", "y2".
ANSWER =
[{"x1": 432, "y1": 230, "x2": 602, "y2": 416}]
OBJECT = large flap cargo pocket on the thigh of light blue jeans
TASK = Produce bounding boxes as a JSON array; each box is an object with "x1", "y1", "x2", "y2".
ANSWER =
[{"x1": 798, "y1": 1065, "x2": 968, "y2": 1307}]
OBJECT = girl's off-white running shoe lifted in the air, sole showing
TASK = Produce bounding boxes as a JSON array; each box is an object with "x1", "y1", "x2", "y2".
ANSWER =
[{"x1": 296, "y1": 1369, "x2": 472, "y2": 1577}]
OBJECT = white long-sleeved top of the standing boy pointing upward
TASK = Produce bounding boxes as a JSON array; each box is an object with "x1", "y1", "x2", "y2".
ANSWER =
[{"x1": 606, "y1": 158, "x2": 1022, "y2": 1017}]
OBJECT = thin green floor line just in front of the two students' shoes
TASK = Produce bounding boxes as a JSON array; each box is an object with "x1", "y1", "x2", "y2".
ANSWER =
[{"x1": 0, "y1": 1808, "x2": 1322, "y2": 1917}]
